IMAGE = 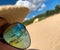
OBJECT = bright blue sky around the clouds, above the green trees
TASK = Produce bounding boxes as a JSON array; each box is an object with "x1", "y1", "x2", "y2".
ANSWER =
[{"x1": 0, "y1": 0, "x2": 60, "y2": 20}]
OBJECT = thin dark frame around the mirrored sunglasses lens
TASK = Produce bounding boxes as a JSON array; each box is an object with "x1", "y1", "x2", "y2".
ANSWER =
[{"x1": 0, "y1": 22, "x2": 31, "y2": 50}]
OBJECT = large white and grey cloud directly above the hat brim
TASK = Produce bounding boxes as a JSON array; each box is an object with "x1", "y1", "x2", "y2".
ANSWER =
[{"x1": 15, "y1": 0, "x2": 45, "y2": 11}]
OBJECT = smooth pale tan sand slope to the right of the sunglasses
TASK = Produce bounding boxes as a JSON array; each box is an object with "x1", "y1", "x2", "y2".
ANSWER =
[{"x1": 27, "y1": 14, "x2": 60, "y2": 50}]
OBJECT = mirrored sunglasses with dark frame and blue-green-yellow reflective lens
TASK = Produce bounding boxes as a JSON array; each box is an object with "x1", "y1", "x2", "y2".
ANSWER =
[{"x1": 0, "y1": 23, "x2": 31, "y2": 49}]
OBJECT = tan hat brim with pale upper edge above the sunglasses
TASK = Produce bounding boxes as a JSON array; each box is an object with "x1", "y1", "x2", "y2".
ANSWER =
[{"x1": 0, "y1": 5, "x2": 29, "y2": 23}]
